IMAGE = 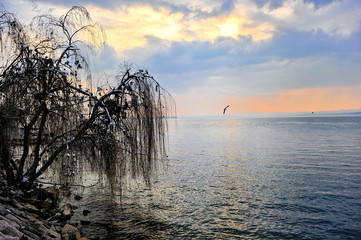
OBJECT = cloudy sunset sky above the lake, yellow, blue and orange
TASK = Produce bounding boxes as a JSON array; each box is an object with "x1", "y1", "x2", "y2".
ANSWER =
[{"x1": 0, "y1": 0, "x2": 361, "y2": 116}]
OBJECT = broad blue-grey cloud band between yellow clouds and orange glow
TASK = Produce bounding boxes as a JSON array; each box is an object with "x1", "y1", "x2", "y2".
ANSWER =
[{"x1": 136, "y1": 23, "x2": 361, "y2": 96}]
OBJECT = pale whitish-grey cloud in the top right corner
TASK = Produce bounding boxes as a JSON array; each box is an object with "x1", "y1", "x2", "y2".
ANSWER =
[{"x1": 262, "y1": 0, "x2": 361, "y2": 36}]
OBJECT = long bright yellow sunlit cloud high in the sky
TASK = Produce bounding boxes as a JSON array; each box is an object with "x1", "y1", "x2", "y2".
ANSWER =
[{"x1": 89, "y1": 4, "x2": 275, "y2": 51}]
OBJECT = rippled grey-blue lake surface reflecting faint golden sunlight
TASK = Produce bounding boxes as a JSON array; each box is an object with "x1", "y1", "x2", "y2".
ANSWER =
[{"x1": 69, "y1": 116, "x2": 361, "y2": 239}]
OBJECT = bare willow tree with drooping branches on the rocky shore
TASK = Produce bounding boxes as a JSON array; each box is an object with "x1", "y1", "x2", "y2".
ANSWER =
[{"x1": 0, "y1": 6, "x2": 171, "y2": 188}]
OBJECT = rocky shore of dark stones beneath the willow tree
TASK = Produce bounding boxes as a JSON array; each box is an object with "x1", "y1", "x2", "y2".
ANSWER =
[{"x1": 0, "y1": 181, "x2": 88, "y2": 240}]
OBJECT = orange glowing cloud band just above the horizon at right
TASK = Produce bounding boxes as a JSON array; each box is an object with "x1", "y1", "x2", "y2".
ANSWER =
[{"x1": 227, "y1": 86, "x2": 361, "y2": 113}]
